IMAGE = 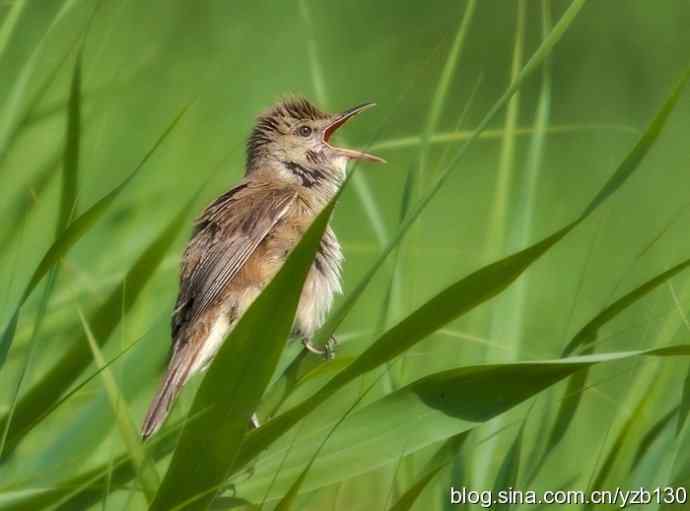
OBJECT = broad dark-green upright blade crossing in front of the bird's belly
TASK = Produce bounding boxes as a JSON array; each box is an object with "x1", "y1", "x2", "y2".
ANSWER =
[{"x1": 151, "y1": 188, "x2": 342, "y2": 511}]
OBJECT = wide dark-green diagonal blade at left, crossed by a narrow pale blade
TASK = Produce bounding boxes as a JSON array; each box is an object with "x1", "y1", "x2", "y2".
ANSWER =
[{"x1": 0, "y1": 154, "x2": 199, "y2": 458}]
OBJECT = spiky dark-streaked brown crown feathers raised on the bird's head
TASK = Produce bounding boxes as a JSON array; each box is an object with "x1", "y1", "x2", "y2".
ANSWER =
[{"x1": 247, "y1": 96, "x2": 329, "y2": 169}]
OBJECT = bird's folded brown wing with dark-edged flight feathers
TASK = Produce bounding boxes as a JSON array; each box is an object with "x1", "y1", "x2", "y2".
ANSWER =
[{"x1": 172, "y1": 181, "x2": 297, "y2": 345}]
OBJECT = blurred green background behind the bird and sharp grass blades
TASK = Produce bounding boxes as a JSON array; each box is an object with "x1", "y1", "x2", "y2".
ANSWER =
[{"x1": 0, "y1": 0, "x2": 690, "y2": 510}]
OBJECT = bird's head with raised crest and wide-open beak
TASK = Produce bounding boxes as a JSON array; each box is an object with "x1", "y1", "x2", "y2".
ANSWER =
[{"x1": 247, "y1": 98, "x2": 384, "y2": 186}]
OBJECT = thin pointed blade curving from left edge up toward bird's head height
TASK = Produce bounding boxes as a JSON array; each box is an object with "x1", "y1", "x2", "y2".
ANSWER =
[{"x1": 0, "y1": 107, "x2": 186, "y2": 369}]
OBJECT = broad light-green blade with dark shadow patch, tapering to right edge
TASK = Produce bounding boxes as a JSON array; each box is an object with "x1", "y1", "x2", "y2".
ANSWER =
[{"x1": 233, "y1": 344, "x2": 690, "y2": 500}]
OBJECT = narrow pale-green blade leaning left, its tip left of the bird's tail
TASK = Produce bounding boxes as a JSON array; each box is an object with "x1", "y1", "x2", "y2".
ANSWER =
[{"x1": 78, "y1": 309, "x2": 160, "y2": 502}]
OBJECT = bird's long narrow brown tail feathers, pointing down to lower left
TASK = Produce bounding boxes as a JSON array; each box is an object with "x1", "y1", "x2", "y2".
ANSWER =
[{"x1": 140, "y1": 343, "x2": 195, "y2": 440}]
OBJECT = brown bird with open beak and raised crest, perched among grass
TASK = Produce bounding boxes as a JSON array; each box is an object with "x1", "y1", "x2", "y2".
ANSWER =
[{"x1": 140, "y1": 96, "x2": 385, "y2": 440}]
